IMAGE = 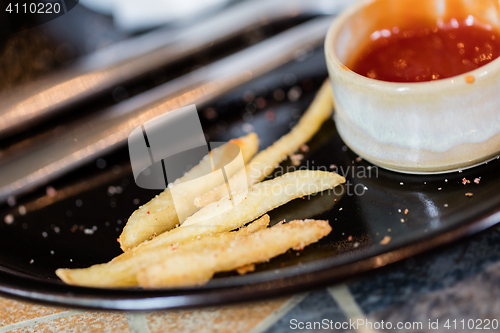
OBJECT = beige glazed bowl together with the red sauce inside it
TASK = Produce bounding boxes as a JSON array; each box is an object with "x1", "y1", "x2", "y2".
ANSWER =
[{"x1": 325, "y1": 0, "x2": 500, "y2": 174}]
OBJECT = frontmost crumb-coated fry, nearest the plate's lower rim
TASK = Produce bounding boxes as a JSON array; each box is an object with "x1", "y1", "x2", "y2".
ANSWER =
[{"x1": 137, "y1": 220, "x2": 332, "y2": 288}]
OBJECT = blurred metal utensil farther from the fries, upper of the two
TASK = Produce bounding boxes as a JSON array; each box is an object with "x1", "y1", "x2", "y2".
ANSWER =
[{"x1": 0, "y1": 0, "x2": 352, "y2": 137}]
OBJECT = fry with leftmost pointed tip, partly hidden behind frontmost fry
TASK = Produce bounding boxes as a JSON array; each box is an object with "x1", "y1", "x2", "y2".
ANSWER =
[{"x1": 56, "y1": 214, "x2": 269, "y2": 288}]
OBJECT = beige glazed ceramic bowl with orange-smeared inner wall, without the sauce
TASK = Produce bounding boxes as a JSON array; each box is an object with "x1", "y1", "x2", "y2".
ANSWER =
[{"x1": 325, "y1": 0, "x2": 500, "y2": 173}]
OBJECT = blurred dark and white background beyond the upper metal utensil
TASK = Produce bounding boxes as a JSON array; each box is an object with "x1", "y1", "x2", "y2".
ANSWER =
[{"x1": 0, "y1": 0, "x2": 236, "y2": 90}]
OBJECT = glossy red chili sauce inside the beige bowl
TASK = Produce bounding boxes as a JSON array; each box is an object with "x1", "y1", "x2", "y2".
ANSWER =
[{"x1": 348, "y1": 16, "x2": 500, "y2": 82}]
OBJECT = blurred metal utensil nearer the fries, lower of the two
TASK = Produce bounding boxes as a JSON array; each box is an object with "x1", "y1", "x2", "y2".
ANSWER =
[{"x1": 0, "y1": 13, "x2": 348, "y2": 200}]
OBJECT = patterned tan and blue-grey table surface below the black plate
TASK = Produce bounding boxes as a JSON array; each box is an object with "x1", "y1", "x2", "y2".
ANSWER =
[{"x1": 0, "y1": 223, "x2": 500, "y2": 333}]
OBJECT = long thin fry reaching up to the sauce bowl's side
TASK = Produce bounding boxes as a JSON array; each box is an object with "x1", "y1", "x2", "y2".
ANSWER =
[{"x1": 194, "y1": 80, "x2": 333, "y2": 207}]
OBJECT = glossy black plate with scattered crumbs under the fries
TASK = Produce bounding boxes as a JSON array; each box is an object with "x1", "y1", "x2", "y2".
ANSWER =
[{"x1": 0, "y1": 49, "x2": 500, "y2": 310}]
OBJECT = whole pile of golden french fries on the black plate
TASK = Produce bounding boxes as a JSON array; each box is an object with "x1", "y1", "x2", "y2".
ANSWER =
[{"x1": 56, "y1": 79, "x2": 345, "y2": 288}]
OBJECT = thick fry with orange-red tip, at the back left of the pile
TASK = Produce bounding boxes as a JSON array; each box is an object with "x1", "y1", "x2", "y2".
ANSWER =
[{"x1": 119, "y1": 133, "x2": 259, "y2": 251}]
